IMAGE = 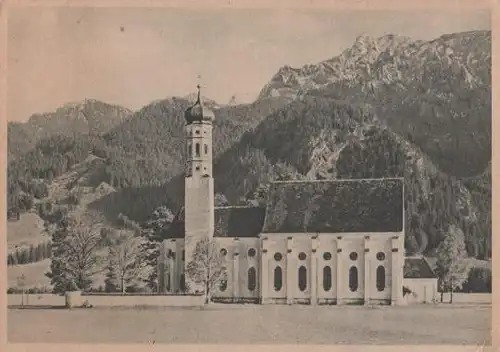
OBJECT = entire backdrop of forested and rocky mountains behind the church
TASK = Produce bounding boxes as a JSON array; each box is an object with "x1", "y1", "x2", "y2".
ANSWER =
[{"x1": 8, "y1": 32, "x2": 491, "y2": 270}]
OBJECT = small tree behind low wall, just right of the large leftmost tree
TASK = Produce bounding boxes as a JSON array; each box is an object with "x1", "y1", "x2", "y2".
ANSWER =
[{"x1": 109, "y1": 231, "x2": 142, "y2": 293}]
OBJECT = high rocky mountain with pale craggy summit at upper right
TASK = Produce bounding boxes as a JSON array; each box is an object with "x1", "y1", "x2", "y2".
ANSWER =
[{"x1": 259, "y1": 31, "x2": 491, "y2": 176}]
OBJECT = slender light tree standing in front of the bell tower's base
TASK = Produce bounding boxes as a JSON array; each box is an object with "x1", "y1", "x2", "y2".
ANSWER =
[{"x1": 186, "y1": 238, "x2": 227, "y2": 304}]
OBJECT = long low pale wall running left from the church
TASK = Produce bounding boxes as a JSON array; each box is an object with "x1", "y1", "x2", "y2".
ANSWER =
[{"x1": 7, "y1": 292, "x2": 205, "y2": 307}]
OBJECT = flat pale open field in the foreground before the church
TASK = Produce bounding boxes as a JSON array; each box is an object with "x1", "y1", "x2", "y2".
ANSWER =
[{"x1": 8, "y1": 305, "x2": 491, "y2": 345}]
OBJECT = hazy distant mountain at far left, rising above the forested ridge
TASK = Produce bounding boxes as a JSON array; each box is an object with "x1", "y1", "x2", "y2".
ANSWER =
[{"x1": 7, "y1": 99, "x2": 132, "y2": 160}]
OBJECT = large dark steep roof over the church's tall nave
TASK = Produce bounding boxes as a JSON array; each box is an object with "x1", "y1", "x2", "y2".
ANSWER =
[{"x1": 262, "y1": 178, "x2": 404, "y2": 233}]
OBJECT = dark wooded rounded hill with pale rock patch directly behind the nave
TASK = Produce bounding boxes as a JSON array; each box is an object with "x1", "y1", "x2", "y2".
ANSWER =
[{"x1": 211, "y1": 96, "x2": 491, "y2": 255}]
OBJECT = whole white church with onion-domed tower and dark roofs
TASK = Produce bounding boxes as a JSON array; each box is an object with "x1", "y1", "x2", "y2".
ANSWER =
[{"x1": 158, "y1": 86, "x2": 436, "y2": 305}]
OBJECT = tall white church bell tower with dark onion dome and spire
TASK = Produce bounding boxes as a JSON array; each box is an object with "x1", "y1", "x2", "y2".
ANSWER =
[{"x1": 184, "y1": 85, "x2": 215, "y2": 291}]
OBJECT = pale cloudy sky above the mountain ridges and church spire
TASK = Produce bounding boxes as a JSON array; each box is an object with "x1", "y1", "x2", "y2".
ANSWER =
[{"x1": 7, "y1": 7, "x2": 491, "y2": 121}]
